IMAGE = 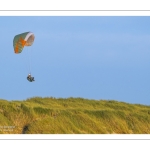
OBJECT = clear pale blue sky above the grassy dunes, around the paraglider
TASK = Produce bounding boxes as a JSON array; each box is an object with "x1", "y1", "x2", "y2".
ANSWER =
[{"x1": 0, "y1": 16, "x2": 150, "y2": 105}]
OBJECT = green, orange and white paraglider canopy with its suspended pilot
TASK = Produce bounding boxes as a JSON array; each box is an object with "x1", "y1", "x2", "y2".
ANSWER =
[{"x1": 13, "y1": 32, "x2": 35, "y2": 82}]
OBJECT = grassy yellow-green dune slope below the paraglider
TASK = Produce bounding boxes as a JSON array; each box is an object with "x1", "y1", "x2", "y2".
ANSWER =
[{"x1": 0, "y1": 97, "x2": 150, "y2": 134}]
